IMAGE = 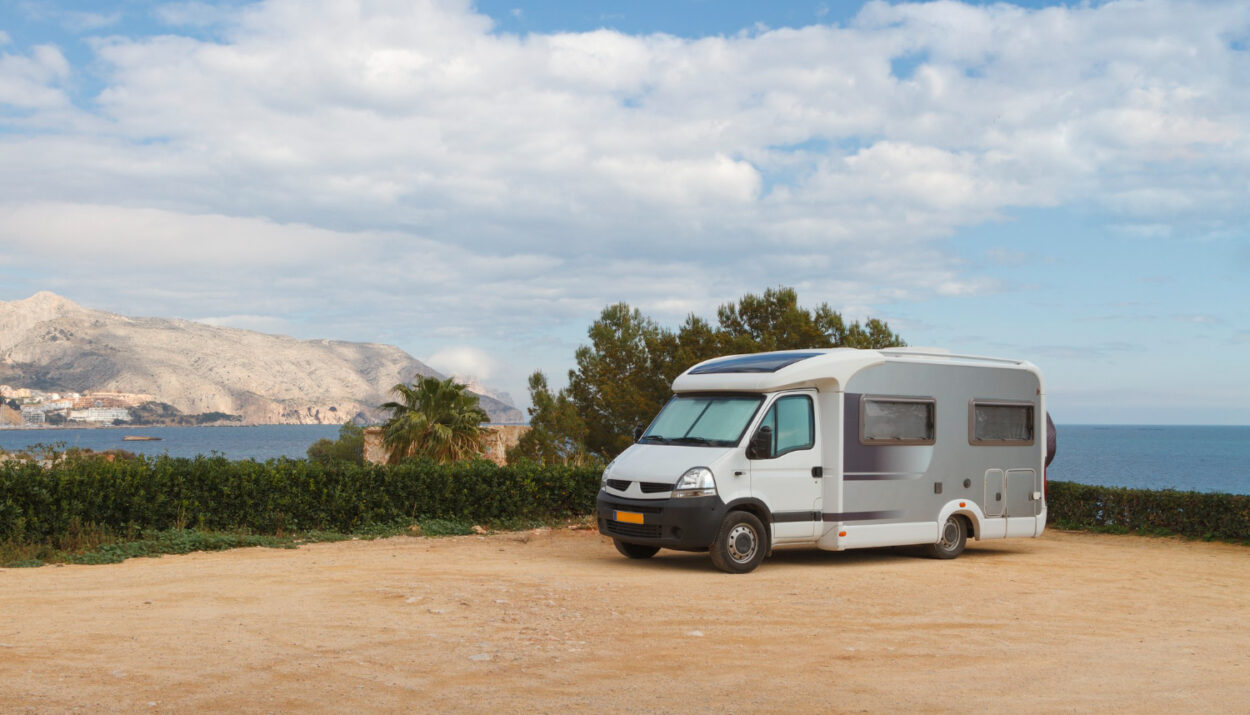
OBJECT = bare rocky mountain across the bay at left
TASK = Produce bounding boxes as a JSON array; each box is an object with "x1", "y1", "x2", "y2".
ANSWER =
[{"x1": 0, "y1": 291, "x2": 524, "y2": 424}]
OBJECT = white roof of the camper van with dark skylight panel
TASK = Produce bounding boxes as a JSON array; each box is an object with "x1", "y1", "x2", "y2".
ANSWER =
[{"x1": 673, "y1": 348, "x2": 1041, "y2": 393}]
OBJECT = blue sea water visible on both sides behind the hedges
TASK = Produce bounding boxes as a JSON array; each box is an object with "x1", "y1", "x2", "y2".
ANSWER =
[{"x1": 0, "y1": 425, "x2": 1250, "y2": 494}]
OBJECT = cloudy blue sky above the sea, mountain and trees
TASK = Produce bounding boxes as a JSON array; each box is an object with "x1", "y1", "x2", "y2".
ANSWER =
[{"x1": 0, "y1": 0, "x2": 1250, "y2": 425}]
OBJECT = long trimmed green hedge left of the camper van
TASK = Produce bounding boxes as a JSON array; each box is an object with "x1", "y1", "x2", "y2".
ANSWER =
[{"x1": 0, "y1": 456, "x2": 600, "y2": 544}]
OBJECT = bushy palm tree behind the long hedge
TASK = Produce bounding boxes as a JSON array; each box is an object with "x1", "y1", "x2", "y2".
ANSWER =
[{"x1": 380, "y1": 375, "x2": 489, "y2": 463}]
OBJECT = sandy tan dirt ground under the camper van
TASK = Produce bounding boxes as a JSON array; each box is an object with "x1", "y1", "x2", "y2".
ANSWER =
[{"x1": 0, "y1": 529, "x2": 1250, "y2": 713}]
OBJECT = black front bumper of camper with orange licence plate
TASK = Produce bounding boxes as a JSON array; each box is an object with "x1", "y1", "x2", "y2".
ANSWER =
[{"x1": 595, "y1": 490, "x2": 726, "y2": 551}]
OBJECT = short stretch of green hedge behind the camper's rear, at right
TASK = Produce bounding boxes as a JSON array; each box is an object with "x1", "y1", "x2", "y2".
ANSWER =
[{"x1": 1046, "y1": 481, "x2": 1250, "y2": 541}]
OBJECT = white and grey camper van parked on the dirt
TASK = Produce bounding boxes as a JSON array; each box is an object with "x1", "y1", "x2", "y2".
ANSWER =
[{"x1": 596, "y1": 348, "x2": 1048, "y2": 574}]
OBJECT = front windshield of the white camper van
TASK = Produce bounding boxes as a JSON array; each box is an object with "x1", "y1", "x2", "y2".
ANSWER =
[{"x1": 639, "y1": 395, "x2": 764, "y2": 446}]
